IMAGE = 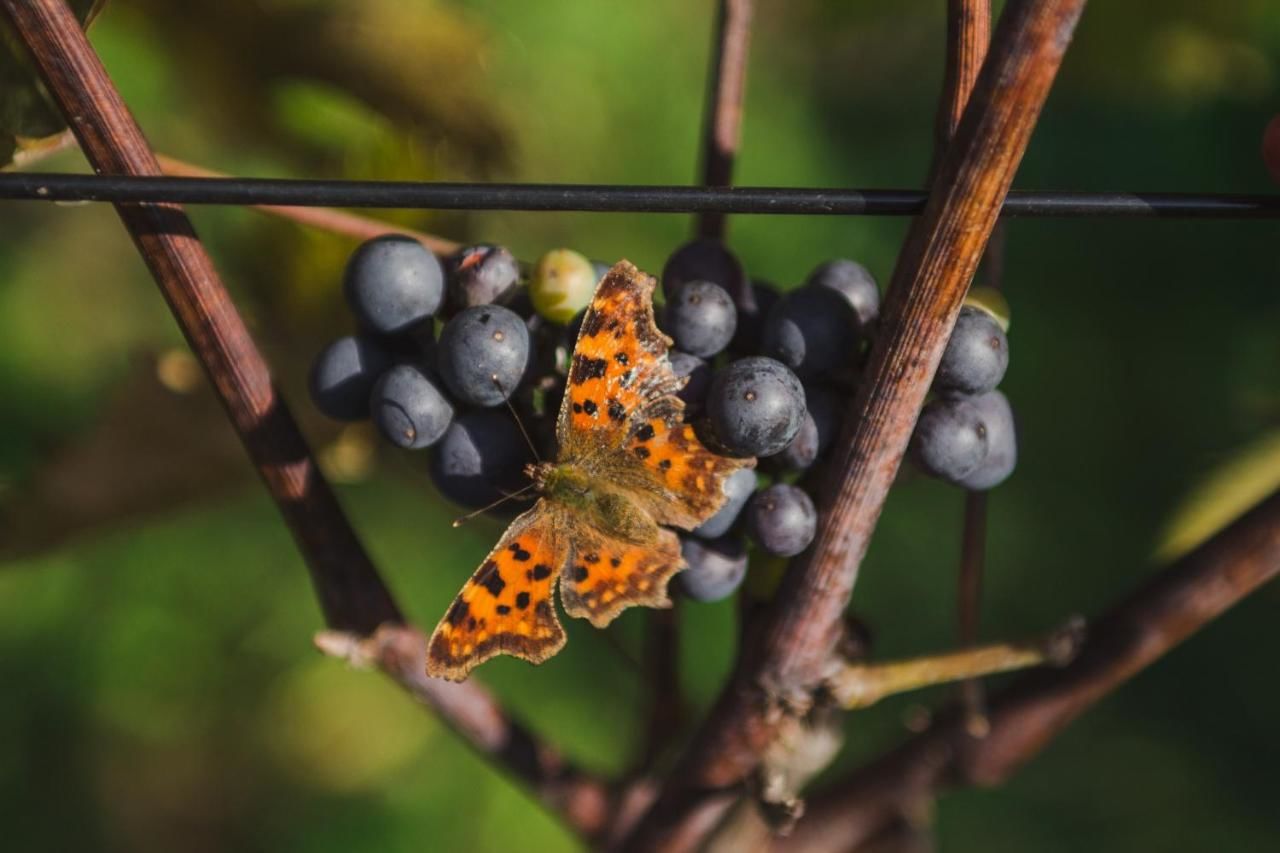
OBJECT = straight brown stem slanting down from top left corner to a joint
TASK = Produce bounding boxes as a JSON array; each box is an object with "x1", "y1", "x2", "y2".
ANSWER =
[{"x1": 0, "y1": 0, "x2": 401, "y2": 631}]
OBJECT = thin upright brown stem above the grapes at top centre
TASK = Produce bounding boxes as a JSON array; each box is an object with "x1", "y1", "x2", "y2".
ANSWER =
[{"x1": 698, "y1": 0, "x2": 755, "y2": 240}]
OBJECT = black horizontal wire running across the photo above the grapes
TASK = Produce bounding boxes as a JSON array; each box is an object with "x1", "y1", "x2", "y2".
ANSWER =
[{"x1": 0, "y1": 173, "x2": 1280, "y2": 219}]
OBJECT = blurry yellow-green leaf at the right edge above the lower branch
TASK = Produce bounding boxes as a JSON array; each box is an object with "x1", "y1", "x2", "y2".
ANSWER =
[{"x1": 1156, "y1": 430, "x2": 1280, "y2": 561}]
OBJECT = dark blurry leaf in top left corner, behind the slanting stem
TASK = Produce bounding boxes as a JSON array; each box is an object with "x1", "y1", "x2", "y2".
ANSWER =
[{"x1": 0, "y1": 0, "x2": 106, "y2": 168}]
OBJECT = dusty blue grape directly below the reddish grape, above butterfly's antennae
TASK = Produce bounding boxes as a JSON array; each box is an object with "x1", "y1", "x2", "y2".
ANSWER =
[{"x1": 438, "y1": 305, "x2": 530, "y2": 406}]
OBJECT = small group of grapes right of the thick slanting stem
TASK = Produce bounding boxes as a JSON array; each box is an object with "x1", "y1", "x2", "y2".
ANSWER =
[{"x1": 911, "y1": 288, "x2": 1018, "y2": 491}]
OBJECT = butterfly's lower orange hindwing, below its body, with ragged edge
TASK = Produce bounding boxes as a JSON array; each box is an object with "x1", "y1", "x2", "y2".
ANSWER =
[{"x1": 561, "y1": 528, "x2": 684, "y2": 628}]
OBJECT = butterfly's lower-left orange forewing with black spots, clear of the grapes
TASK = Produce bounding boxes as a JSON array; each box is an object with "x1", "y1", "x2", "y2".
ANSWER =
[{"x1": 426, "y1": 500, "x2": 570, "y2": 681}]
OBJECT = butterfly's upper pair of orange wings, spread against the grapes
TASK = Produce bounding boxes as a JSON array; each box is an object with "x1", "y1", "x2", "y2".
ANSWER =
[{"x1": 558, "y1": 261, "x2": 755, "y2": 529}]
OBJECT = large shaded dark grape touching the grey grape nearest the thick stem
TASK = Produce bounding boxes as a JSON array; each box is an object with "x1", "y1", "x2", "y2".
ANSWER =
[{"x1": 760, "y1": 286, "x2": 859, "y2": 379}]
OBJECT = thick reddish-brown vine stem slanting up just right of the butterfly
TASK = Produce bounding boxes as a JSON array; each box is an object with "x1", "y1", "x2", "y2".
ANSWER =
[{"x1": 628, "y1": 0, "x2": 1084, "y2": 849}]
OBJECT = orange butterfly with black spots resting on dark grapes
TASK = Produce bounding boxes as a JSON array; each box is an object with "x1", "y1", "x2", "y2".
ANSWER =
[{"x1": 426, "y1": 260, "x2": 755, "y2": 681}]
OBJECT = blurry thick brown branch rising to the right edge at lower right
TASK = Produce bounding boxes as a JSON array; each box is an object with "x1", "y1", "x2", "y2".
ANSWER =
[{"x1": 780, "y1": 492, "x2": 1280, "y2": 852}]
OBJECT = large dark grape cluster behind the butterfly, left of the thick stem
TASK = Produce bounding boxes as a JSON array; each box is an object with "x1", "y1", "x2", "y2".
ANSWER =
[{"x1": 311, "y1": 236, "x2": 879, "y2": 601}]
